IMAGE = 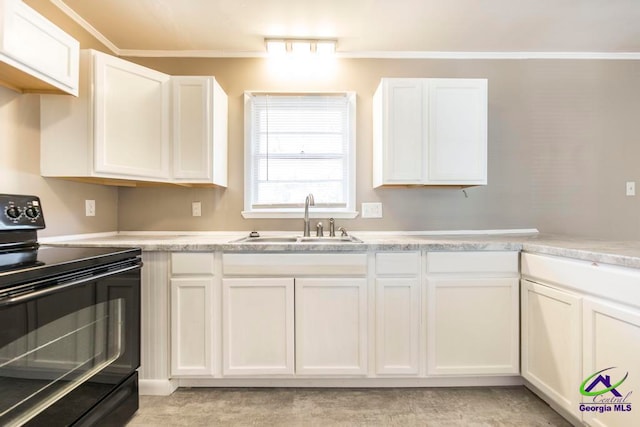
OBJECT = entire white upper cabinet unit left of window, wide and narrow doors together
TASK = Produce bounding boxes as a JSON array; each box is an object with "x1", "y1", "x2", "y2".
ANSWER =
[{"x1": 40, "y1": 50, "x2": 227, "y2": 185}]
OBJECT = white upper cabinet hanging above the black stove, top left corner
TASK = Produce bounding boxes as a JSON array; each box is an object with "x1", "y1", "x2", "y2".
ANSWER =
[{"x1": 0, "y1": 0, "x2": 80, "y2": 95}]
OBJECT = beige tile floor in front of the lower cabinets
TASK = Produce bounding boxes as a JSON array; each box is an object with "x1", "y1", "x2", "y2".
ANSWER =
[{"x1": 128, "y1": 387, "x2": 570, "y2": 427}]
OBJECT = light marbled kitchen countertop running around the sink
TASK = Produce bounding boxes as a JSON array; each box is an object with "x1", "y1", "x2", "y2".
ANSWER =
[{"x1": 40, "y1": 230, "x2": 640, "y2": 268}]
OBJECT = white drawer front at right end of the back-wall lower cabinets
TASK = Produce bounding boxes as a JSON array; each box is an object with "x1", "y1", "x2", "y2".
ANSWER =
[{"x1": 427, "y1": 251, "x2": 518, "y2": 275}]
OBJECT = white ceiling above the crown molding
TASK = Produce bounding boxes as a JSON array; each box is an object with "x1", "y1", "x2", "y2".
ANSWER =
[{"x1": 51, "y1": 0, "x2": 640, "y2": 57}]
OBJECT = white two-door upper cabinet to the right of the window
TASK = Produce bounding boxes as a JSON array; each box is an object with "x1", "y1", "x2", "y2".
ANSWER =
[{"x1": 373, "y1": 78, "x2": 487, "y2": 187}]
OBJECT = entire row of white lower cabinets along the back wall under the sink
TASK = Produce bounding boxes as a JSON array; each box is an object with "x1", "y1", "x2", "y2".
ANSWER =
[{"x1": 170, "y1": 250, "x2": 532, "y2": 386}]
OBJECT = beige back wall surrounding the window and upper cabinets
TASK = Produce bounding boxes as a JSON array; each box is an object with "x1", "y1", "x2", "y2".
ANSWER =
[{"x1": 114, "y1": 58, "x2": 640, "y2": 239}]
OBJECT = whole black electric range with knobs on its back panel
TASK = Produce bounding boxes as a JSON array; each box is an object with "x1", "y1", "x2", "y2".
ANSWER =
[{"x1": 0, "y1": 194, "x2": 142, "y2": 426}]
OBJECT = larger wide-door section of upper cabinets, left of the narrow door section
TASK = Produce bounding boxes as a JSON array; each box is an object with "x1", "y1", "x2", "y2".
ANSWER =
[{"x1": 40, "y1": 50, "x2": 170, "y2": 181}]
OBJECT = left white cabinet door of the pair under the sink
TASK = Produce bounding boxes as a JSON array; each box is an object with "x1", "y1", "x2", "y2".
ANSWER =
[{"x1": 222, "y1": 278, "x2": 294, "y2": 376}]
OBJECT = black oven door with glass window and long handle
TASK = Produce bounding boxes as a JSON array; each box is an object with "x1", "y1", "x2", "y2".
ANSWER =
[{"x1": 0, "y1": 261, "x2": 140, "y2": 426}]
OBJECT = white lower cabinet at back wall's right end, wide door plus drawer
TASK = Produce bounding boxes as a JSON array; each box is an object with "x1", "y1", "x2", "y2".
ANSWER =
[{"x1": 427, "y1": 252, "x2": 520, "y2": 376}]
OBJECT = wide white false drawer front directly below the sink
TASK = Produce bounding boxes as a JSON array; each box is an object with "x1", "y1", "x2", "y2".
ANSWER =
[{"x1": 222, "y1": 254, "x2": 367, "y2": 276}]
